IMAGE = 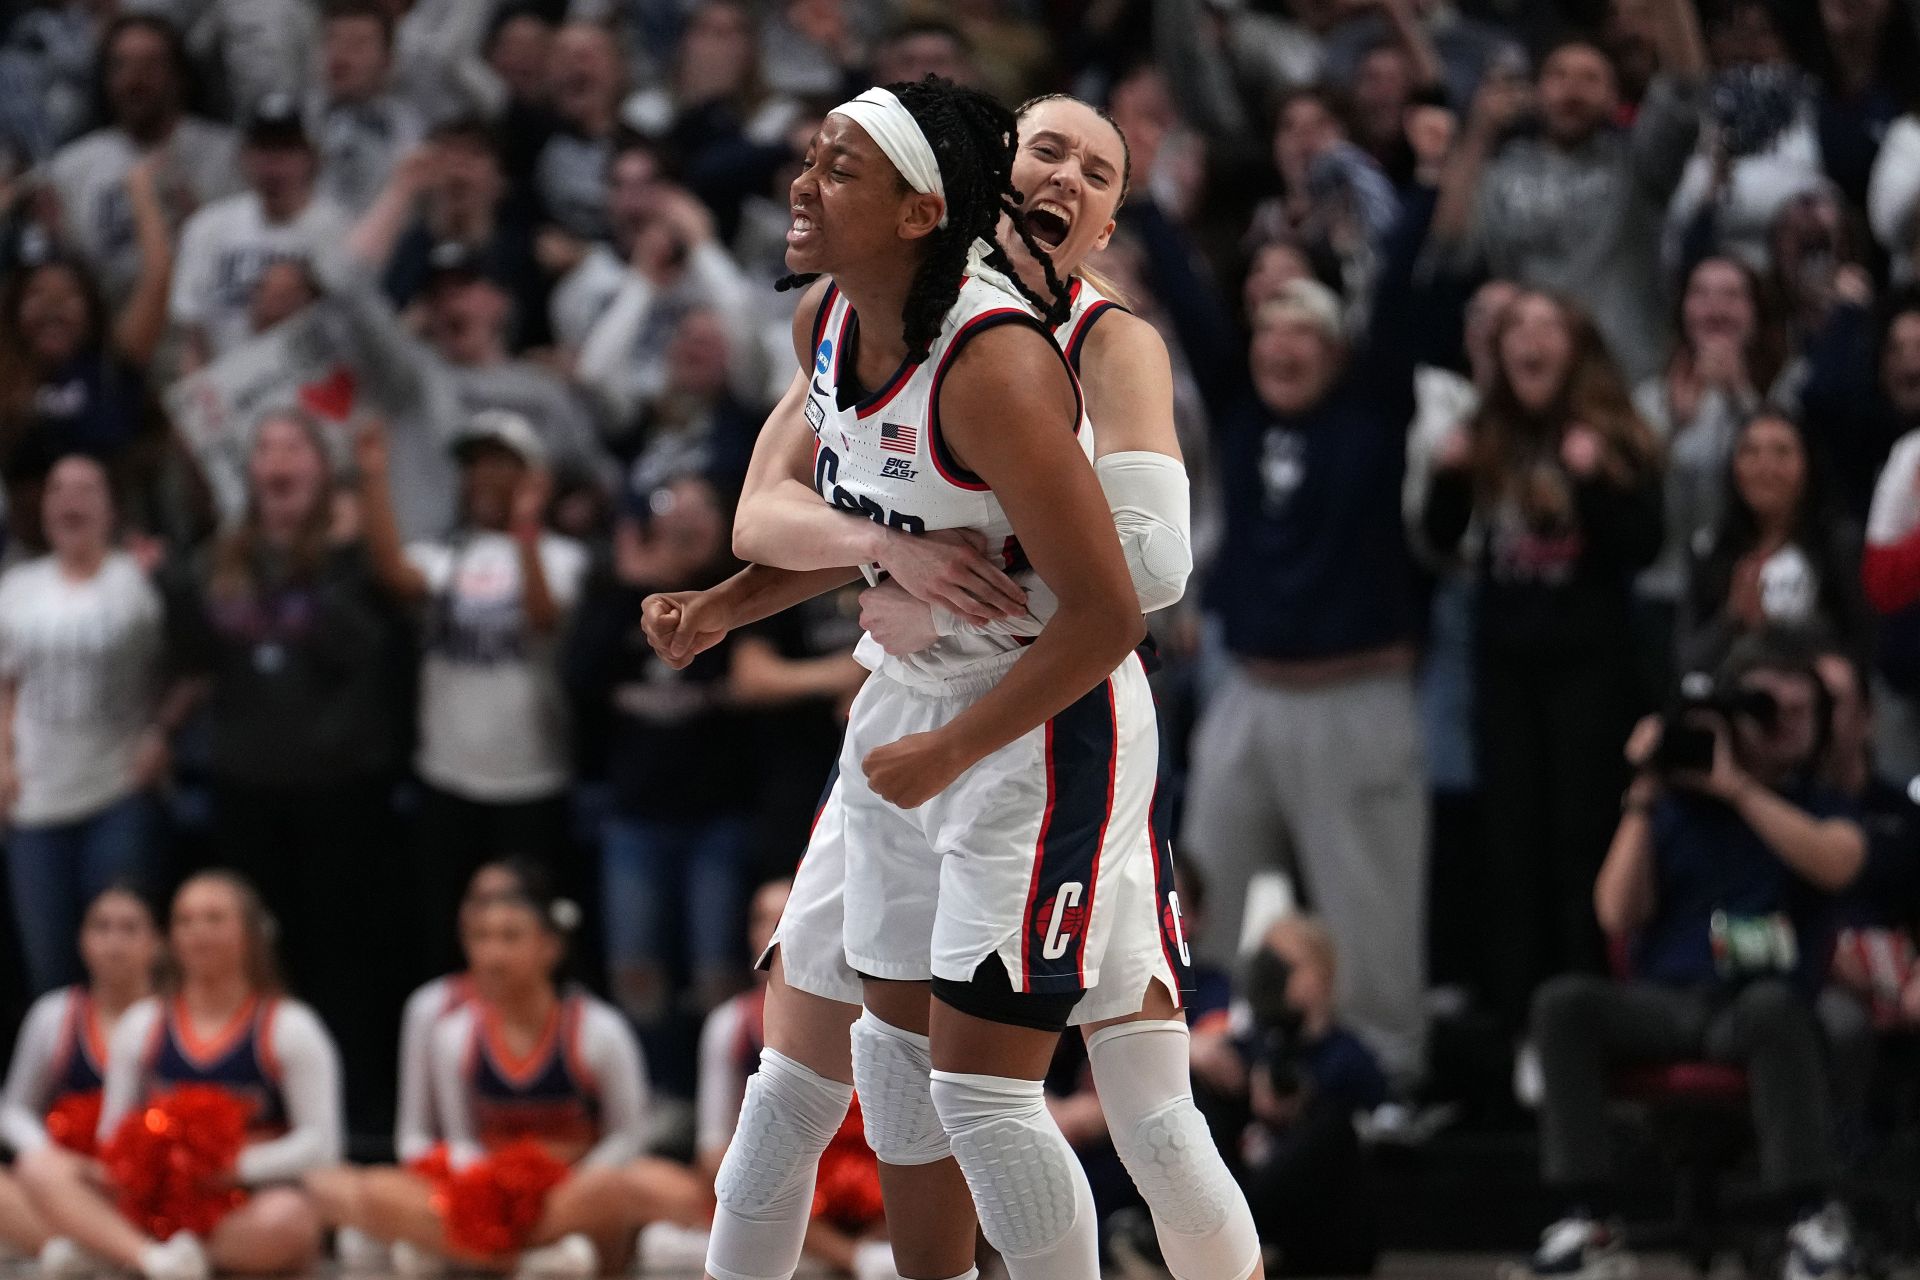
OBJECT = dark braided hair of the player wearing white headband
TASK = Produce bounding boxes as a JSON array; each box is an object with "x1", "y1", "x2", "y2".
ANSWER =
[{"x1": 774, "y1": 75, "x2": 1069, "y2": 365}]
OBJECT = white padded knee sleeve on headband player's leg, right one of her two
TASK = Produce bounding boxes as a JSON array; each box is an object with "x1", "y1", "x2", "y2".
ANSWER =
[{"x1": 933, "y1": 1071, "x2": 1100, "y2": 1280}]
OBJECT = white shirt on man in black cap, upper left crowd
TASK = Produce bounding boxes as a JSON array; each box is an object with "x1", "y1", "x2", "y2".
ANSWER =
[{"x1": 169, "y1": 192, "x2": 353, "y2": 357}]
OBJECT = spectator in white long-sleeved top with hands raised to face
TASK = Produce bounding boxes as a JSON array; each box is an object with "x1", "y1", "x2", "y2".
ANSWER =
[{"x1": 553, "y1": 136, "x2": 758, "y2": 436}]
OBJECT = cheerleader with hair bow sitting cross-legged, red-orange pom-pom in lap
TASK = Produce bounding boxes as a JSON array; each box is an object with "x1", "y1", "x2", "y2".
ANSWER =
[{"x1": 326, "y1": 869, "x2": 710, "y2": 1276}]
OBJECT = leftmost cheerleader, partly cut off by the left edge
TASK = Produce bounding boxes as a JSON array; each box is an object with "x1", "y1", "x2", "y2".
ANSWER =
[{"x1": 0, "y1": 885, "x2": 159, "y2": 1274}]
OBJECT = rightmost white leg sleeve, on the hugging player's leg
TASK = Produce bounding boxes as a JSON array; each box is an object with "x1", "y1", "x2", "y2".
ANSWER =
[{"x1": 1087, "y1": 1021, "x2": 1260, "y2": 1280}]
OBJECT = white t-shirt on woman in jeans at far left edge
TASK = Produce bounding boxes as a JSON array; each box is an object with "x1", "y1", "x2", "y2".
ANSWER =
[{"x1": 0, "y1": 553, "x2": 161, "y2": 825}]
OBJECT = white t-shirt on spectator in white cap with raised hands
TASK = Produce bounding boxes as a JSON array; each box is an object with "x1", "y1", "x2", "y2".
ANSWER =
[{"x1": 407, "y1": 533, "x2": 588, "y2": 804}]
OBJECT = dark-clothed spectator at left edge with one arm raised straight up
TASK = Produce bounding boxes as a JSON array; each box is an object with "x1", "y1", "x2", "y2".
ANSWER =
[{"x1": 0, "y1": 216, "x2": 205, "y2": 549}]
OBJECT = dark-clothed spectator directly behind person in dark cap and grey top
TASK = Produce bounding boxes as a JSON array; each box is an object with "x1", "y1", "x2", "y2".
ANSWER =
[{"x1": 353, "y1": 119, "x2": 553, "y2": 351}]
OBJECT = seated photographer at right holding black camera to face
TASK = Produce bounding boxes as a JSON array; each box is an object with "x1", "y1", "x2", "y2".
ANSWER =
[{"x1": 1534, "y1": 633, "x2": 1866, "y2": 1274}]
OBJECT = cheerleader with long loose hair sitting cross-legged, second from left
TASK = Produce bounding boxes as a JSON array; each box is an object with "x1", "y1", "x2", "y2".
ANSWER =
[{"x1": 19, "y1": 871, "x2": 342, "y2": 1280}]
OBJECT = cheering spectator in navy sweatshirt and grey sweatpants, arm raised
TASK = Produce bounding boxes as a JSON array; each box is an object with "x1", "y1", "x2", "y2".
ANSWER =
[{"x1": 1183, "y1": 177, "x2": 1432, "y2": 1080}]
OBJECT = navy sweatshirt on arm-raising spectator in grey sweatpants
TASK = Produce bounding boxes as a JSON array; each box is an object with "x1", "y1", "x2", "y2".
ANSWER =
[{"x1": 1206, "y1": 192, "x2": 1432, "y2": 662}]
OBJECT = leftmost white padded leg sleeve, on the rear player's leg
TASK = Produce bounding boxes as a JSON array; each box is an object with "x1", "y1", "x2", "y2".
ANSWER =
[{"x1": 707, "y1": 1050, "x2": 852, "y2": 1280}]
